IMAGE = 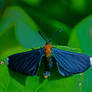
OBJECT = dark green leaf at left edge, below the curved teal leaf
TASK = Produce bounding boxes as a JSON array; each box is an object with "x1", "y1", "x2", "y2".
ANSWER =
[{"x1": 0, "y1": 25, "x2": 23, "y2": 57}]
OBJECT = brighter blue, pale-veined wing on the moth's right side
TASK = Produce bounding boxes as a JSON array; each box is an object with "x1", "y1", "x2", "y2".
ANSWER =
[{"x1": 52, "y1": 48, "x2": 91, "y2": 76}]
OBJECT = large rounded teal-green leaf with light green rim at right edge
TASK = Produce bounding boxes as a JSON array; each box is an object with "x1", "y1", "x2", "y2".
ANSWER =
[{"x1": 69, "y1": 16, "x2": 92, "y2": 56}]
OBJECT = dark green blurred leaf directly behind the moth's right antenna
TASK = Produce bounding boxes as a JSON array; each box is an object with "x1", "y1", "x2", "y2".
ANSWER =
[{"x1": 23, "y1": 9, "x2": 71, "y2": 45}]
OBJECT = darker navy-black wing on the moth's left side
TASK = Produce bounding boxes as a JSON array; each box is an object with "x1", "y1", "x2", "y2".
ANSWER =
[{"x1": 8, "y1": 48, "x2": 44, "y2": 76}]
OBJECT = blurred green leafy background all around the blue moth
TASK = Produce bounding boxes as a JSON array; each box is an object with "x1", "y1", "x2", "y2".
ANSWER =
[{"x1": 0, "y1": 0, "x2": 92, "y2": 92}]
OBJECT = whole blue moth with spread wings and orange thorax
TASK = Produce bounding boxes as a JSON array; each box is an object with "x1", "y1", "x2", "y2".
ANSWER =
[{"x1": 2, "y1": 29, "x2": 92, "y2": 78}]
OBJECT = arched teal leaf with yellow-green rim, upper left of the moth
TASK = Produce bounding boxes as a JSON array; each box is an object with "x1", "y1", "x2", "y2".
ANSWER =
[{"x1": 0, "y1": 7, "x2": 45, "y2": 48}]
